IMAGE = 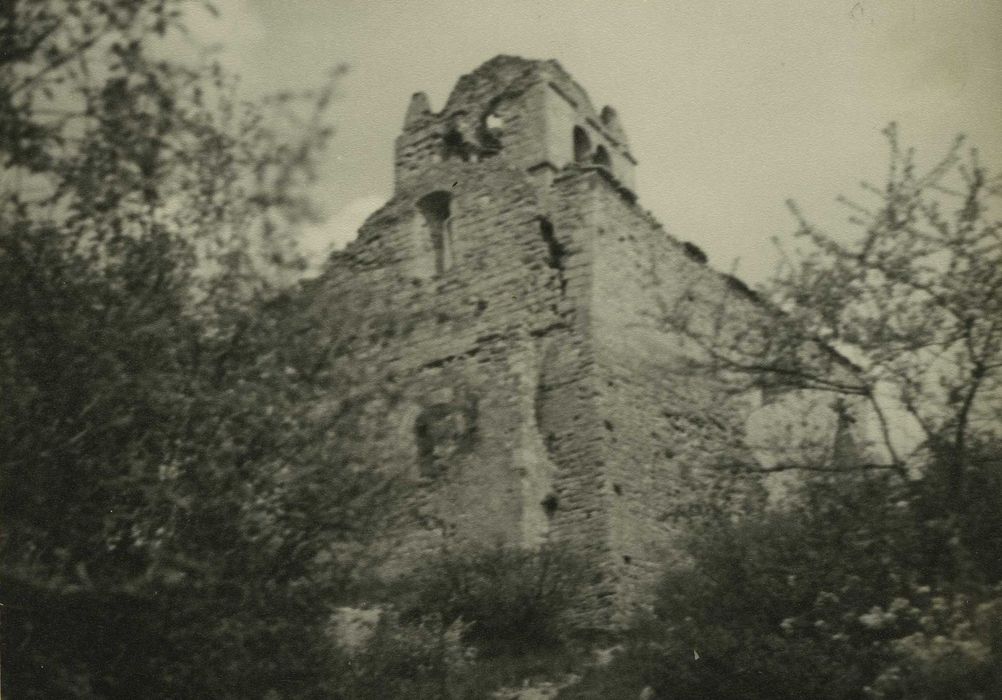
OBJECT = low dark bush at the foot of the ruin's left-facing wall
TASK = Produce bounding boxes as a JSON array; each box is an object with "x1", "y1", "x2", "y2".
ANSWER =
[{"x1": 341, "y1": 544, "x2": 582, "y2": 699}]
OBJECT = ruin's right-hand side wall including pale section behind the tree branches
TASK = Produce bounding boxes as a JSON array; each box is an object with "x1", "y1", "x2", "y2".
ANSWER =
[{"x1": 589, "y1": 167, "x2": 863, "y2": 614}]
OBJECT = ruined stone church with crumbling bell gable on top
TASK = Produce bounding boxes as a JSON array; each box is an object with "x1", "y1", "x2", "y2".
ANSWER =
[{"x1": 313, "y1": 56, "x2": 857, "y2": 619}]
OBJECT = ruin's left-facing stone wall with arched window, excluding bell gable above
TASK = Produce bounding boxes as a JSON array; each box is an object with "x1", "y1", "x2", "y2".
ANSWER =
[{"x1": 314, "y1": 149, "x2": 607, "y2": 596}]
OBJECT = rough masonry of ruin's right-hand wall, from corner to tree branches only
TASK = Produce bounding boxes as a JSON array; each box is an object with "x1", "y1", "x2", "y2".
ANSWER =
[{"x1": 590, "y1": 174, "x2": 763, "y2": 615}]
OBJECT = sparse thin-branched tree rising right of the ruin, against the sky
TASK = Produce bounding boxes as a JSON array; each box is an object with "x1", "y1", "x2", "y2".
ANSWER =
[{"x1": 664, "y1": 124, "x2": 1002, "y2": 498}]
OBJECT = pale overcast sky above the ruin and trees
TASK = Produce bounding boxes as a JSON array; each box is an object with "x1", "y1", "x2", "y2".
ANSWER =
[{"x1": 188, "y1": 0, "x2": 1002, "y2": 281}]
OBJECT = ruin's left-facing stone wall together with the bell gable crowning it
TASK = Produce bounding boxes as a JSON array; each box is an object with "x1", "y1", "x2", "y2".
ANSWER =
[{"x1": 306, "y1": 57, "x2": 649, "y2": 604}]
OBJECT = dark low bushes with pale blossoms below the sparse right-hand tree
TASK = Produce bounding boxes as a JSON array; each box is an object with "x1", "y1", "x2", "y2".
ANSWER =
[{"x1": 567, "y1": 456, "x2": 1002, "y2": 698}]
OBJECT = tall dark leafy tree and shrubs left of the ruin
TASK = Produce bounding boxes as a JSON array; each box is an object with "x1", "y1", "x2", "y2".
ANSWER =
[{"x1": 0, "y1": 0, "x2": 367, "y2": 697}]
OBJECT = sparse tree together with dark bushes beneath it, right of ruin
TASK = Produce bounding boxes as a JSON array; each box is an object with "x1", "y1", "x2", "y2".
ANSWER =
[{"x1": 561, "y1": 125, "x2": 1002, "y2": 700}]
